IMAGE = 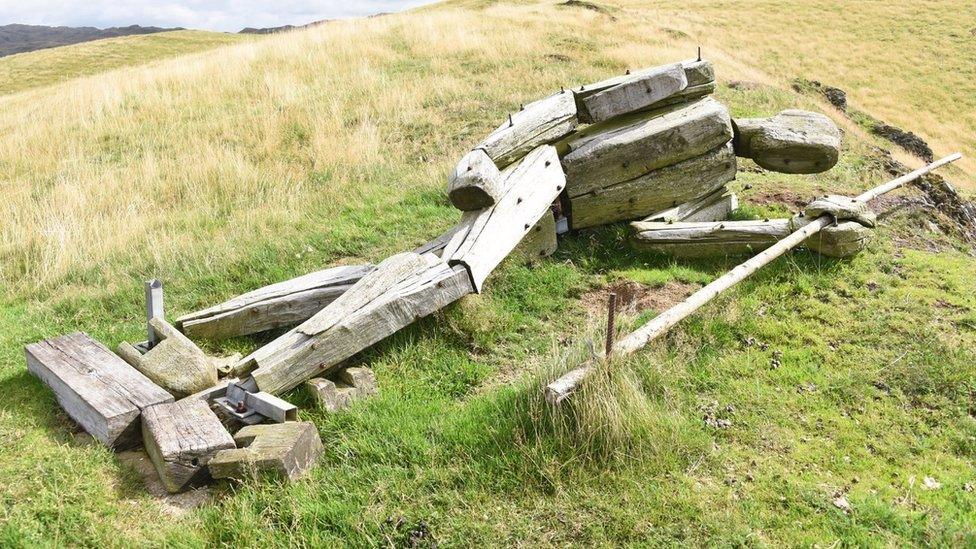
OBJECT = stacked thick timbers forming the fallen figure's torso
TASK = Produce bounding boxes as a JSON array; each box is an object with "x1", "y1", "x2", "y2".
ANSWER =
[{"x1": 559, "y1": 61, "x2": 736, "y2": 228}]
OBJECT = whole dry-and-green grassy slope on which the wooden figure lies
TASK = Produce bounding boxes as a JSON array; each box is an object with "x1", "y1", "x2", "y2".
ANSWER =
[{"x1": 0, "y1": 2, "x2": 976, "y2": 547}]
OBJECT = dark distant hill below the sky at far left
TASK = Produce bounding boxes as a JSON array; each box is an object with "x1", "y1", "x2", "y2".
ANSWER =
[{"x1": 0, "y1": 24, "x2": 183, "y2": 57}]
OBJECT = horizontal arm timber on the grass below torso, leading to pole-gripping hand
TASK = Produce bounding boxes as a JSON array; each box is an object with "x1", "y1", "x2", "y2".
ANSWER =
[{"x1": 631, "y1": 219, "x2": 798, "y2": 257}]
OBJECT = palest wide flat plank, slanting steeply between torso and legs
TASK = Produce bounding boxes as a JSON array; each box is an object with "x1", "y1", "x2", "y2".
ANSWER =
[{"x1": 445, "y1": 145, "x2": 566, "y2": 292}]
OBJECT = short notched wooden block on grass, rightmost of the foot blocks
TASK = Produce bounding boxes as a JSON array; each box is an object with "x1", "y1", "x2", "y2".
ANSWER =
[{"x1": 209, "y1": 421, "x2": 324, "y2": 480}]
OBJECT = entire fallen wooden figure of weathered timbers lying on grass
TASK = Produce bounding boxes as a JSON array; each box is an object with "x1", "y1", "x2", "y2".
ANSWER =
[{"x1": 26, "y1": 56, "x2": 904, "y2": 491}]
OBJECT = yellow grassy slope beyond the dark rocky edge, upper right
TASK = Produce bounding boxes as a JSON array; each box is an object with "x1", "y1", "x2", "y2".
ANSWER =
[{"x1": 632, "y1": 0, "x2": 976, "y2": 188}]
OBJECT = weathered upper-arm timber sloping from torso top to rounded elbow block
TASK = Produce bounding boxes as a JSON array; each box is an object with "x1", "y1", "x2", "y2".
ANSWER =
[{"x1": 476, "y1": 91, "x2": 578, "y2": 168}]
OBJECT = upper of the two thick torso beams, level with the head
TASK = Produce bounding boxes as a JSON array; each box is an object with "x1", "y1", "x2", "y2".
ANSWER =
[{"x1": 563, "y1": 98, "x2": 732, "y2": 197}]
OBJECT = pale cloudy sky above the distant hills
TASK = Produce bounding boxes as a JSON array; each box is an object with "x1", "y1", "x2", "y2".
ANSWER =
[{"x1": 0, "y1": 0, "x2": 430, "y2": 32}]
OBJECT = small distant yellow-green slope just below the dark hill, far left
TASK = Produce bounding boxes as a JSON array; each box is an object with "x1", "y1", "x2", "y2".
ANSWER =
[{"x1": 0, "y1": 31, "x2": 248, "y2": 94}]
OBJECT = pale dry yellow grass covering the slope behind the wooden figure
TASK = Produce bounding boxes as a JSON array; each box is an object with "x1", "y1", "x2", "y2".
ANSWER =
[{"x1": 0, "y1": 2, "x2": 976, "y2": 296}]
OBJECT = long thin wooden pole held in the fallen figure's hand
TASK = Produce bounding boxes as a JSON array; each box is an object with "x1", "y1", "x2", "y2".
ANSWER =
[{"x1": 545, "y1": 153, "x2": 962, "y2": 404}]
